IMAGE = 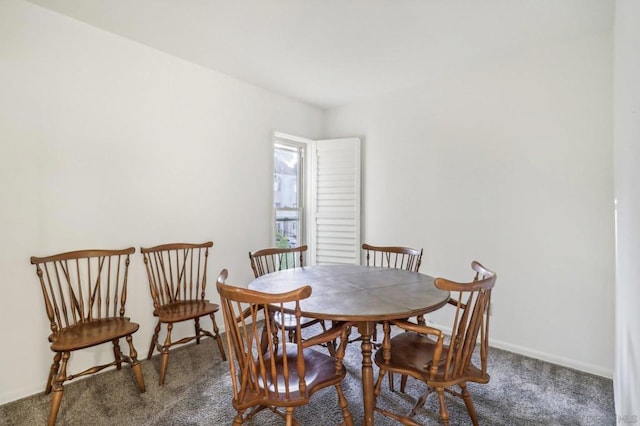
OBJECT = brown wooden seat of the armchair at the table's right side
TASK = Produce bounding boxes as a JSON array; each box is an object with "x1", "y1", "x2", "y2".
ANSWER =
[{"x1": 375, "y1": 331, "x2": 489, "y2": 383}]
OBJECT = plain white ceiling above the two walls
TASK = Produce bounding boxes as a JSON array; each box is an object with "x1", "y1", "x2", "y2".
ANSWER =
[{"x1": 29, "y1": 0, "x2": 614, "y2": 108}]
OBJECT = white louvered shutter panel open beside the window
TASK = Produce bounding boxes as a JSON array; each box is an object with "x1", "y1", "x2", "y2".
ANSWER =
[{"x1": 309, "y1": 138, "x2": 360, "y2": 265}]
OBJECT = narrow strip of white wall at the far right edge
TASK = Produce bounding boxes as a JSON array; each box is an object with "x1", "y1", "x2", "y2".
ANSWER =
[{"x1": 614, "y1": 0, "x2": 640, "y2": 423}]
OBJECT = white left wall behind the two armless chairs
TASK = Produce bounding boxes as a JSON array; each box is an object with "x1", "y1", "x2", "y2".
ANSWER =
[{"x1": 0, "y1": 0, "x2": 324, "y2": 403}]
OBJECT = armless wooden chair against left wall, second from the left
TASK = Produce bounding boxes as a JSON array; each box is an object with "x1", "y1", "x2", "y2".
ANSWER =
[{"x1": 140, "y1": 241, "x2": 226, "y2": 385}]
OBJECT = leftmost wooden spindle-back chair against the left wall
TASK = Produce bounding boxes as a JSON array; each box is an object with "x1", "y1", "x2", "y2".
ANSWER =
[{"x1": 31, "y1": 247, "x2": 145, "y2": 426}]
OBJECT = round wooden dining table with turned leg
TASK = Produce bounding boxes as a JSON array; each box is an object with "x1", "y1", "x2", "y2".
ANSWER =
[{"x1": 249, "y1": 265, "x2": 450, "y2": 426}]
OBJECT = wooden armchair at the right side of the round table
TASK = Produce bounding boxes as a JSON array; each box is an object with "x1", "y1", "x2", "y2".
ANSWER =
[{"x1": 374, "y1": 261, "x2": 496, "y2": 425}]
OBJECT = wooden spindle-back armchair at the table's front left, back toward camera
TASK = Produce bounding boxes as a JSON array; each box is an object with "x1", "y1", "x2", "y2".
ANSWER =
[{"x1": 217, "y1": 269, "x2": 353, "y2": 426}]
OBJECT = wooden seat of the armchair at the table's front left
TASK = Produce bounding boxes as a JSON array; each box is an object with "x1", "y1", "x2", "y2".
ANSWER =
[{"x1": 256, "y1": 343, "x2": 347, "y2": 406}]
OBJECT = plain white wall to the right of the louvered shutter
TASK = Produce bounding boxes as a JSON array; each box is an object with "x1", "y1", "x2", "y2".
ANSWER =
[{"x1": 327, "y1": 34, "x2": 614, "y2": 377}]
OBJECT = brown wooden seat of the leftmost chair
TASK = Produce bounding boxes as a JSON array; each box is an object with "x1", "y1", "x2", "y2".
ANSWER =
[{"x1": 49, "y1": 318, "x2": 140, "y2": 352}]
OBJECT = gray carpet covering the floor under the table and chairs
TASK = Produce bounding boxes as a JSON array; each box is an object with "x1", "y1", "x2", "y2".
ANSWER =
[{"x1": 0, "y1": 326, "x2": 616, "y2": 426}]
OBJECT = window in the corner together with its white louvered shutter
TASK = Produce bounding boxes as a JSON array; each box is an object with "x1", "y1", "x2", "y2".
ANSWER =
[{"x1": 273, "y1": 133, "x2": 361, "y2": 265}]
